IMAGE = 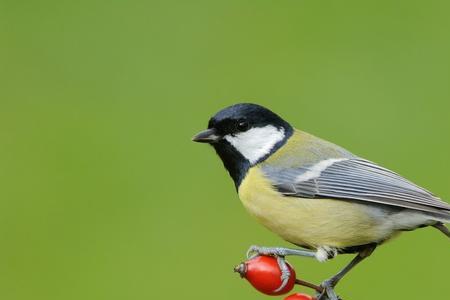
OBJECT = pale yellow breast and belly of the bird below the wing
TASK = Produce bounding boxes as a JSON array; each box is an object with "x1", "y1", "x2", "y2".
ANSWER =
[{"x1": 238, "y1": 166, "x2": 388, "y2": 248}]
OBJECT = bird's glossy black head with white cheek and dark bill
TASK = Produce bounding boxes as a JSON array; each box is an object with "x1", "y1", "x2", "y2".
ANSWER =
[{"x1": 192, "y1": 103, "x2": 293, "y2": 186}]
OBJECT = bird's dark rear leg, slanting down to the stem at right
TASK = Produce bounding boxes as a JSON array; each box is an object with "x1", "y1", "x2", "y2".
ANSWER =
[{"x1": 317, "y1": 245, "x2": 376, "y2": 300}]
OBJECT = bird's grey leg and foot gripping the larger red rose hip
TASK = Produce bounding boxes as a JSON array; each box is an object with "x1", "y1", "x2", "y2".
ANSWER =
[{"x1": 247, "y1": 246, "x2": 315, "y2": 292}]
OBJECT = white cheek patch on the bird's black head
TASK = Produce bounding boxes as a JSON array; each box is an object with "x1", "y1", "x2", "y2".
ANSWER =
[{"x1": 225, "y1": 125, "x2": 285, "y2": 164}]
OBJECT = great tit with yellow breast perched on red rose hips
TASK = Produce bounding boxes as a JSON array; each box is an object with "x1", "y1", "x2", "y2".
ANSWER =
[{"x1": 192, "y1": 103, "x2": 450, "y2": 300}]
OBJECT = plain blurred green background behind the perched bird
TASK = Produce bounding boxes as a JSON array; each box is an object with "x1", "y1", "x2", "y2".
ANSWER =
[{"x1": 0, "y1": 0, "x2": 450, "y2": 300}]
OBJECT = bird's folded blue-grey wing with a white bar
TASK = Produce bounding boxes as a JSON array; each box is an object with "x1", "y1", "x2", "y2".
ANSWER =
[{"x1": 263, "y1": 158, "x2": 450, "y2": 219}]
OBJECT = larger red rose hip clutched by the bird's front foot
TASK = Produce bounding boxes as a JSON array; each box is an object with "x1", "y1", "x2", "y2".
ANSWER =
[{"x1": 235, "y1": 256, "x2": 295, "y2": 295}]
